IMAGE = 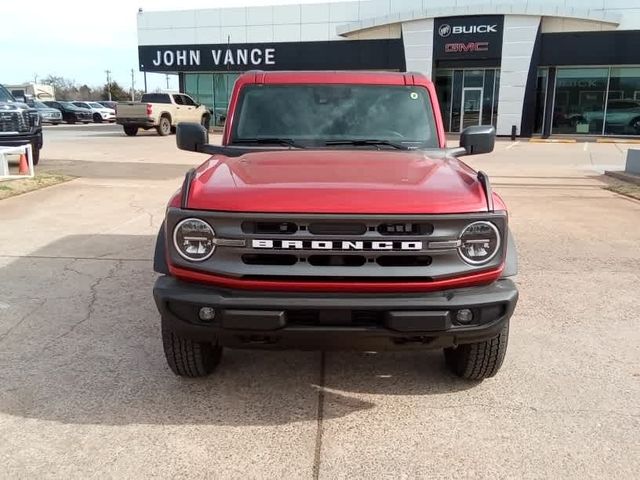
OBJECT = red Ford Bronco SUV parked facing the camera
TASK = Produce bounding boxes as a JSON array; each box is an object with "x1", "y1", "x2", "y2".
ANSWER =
[{"x1": 153, "y1": 71, "x2": 518, "y2": 380}]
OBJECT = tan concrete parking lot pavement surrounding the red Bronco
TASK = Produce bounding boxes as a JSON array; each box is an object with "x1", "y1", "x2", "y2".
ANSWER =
[{"x1": 0, "y1": 126, "x2": 640, "y2": 479}]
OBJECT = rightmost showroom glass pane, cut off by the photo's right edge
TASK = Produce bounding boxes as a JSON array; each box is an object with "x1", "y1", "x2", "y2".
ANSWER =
[{"x1": 604, "y1": 67, "x2": 640, "y2": 135}]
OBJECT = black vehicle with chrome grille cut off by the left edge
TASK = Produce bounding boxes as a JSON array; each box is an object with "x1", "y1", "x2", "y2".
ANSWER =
[{"x1": 0, "y1": 85, "x2": 42, "y2": 165}]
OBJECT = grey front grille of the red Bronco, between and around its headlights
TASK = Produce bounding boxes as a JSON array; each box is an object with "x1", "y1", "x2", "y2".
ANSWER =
[{"x1": 167, "y1": 208, "x2": 506, "y2": 283}]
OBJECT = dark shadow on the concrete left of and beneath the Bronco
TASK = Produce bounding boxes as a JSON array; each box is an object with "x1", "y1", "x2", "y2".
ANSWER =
[{"x1": 0, "y1": 235, "x2": 474, "y2": 426}]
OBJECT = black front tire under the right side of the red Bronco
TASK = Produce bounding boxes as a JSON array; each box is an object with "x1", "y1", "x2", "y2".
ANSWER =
[{"x1": 444, "y1": 323, "x2": 509, "y2": 380}]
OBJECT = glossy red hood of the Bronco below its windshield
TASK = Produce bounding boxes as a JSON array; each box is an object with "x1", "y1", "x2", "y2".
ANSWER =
[{"x1": 188, "y1": 149, "x2": 496, "y2": 214}]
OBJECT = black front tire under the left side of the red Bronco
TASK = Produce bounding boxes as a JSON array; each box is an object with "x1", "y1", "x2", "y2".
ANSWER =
[{"x1": 162, "y1": 322, "x2": 222, "y2": 377}]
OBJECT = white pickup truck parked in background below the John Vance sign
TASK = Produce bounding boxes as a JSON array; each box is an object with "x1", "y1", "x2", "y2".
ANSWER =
[{"x1": 116, "y1": 93, "x2": 211, "y2": 137}]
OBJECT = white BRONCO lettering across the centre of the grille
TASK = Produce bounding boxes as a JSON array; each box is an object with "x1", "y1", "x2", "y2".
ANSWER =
[{"x1": 251, "y1": 239, "x2": 424, "y2": 251}]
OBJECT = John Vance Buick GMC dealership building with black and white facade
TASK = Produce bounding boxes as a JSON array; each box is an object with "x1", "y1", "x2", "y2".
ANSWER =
[{"x1": 138, "y1": 0, "x2": 640, "y2": 137}]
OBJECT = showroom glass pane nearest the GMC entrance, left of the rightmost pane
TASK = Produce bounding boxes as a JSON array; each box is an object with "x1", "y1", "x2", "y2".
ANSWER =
[{"x1": 552, "y1": 68, "x2": 609, "y2": 135}]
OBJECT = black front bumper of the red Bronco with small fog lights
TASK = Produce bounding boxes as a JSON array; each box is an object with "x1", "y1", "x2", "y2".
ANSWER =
[{"x1": 153, "y1": 276, "x2": 518, "y2": 350}]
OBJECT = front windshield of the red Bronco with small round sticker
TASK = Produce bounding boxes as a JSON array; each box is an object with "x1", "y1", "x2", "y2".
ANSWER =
[{"x1": 231, "y1": 85, "x2": 438, "y2": 148}]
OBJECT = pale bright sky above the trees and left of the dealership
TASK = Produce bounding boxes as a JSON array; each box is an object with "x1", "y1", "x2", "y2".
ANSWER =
[{"x1": 0, "y1": 0, "x2": 339, "y2": 89}]
